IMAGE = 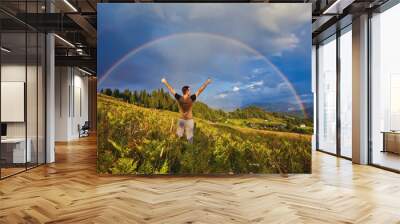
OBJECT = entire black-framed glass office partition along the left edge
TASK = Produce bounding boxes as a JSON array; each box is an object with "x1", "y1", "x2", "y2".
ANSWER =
[{"x1": 0, "y1": 1, "x2": 46, "y2": 179}]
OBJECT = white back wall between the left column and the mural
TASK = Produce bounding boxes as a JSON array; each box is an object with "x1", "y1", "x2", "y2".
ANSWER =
[{"x1": 55, "y1": 67, "x2": 88, "y2": 141}]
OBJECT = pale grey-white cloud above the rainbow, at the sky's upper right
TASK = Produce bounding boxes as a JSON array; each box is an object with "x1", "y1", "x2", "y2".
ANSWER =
[{"x1": 150, "y1": 3, "x2": 311, "y2": 56}]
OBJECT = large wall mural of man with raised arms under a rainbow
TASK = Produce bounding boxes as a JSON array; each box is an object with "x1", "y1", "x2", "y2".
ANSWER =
[{"x1": 97, "y1": 3, "x2": 313, "y2": 175}]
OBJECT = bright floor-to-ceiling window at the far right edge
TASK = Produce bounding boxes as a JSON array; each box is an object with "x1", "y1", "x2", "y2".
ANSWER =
[{"x1": 370, "y1": 1, "x2": 400, "y2": 170}]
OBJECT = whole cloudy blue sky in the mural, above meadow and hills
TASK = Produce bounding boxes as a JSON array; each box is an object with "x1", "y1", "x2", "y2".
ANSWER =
[{"x1": 98, "y1": 3, "x2": 312, "y2": 111}]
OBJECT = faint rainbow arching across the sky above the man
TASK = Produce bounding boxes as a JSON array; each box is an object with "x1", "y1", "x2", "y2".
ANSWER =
[{"x1": 98, "y1": 32, "x2": 307, "y2": 117}]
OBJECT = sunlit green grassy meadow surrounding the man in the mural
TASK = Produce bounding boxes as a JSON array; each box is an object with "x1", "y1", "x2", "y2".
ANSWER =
[{"x1": 97, "y1": 94, "x2": 311, "y2": 174}]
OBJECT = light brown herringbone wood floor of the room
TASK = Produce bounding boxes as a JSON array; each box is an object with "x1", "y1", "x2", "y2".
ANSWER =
[{"x1": 0, "y1": 137, "x2": 400, "y2": 224}]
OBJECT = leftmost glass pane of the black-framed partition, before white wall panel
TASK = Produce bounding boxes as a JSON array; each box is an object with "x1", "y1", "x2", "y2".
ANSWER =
[{"x1": 0, "y1": 31, "x2": 27, "y2": 178}]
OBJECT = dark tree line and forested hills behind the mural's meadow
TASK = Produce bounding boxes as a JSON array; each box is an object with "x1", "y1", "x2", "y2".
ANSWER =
[{"x1": 100, "y1": 89, "x2": 313, "y2": 134}]
